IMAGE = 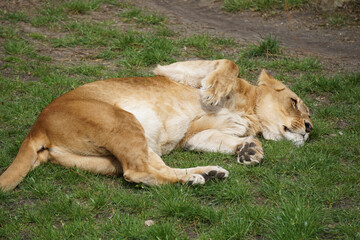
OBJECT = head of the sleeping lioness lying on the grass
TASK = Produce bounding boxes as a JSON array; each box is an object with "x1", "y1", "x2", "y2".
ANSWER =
[{"x1": 256, "y1": 70, "x2": 313, "y2": 146}]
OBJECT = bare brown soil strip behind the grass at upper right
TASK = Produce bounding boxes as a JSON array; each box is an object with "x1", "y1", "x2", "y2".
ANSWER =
[{"x1": 132, "y1": 0, "x2": 360, "y2": 72}]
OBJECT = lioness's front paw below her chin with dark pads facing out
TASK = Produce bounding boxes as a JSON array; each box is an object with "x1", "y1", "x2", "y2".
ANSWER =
[{"x1": 236, "y1": 137, "x2": 264, "y2": 165}]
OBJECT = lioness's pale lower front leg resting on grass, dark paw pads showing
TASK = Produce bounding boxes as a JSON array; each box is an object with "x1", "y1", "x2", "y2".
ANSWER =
[{"x1": 184, "y1": 129, "x2": 264, "y2": 165}]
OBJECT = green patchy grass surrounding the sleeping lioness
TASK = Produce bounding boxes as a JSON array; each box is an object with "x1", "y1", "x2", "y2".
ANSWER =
[{"x1": 0, "y1": 0, "x2": 360, "y2": 239}]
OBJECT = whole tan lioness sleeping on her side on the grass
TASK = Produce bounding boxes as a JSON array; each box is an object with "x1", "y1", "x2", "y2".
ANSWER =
[{"x1": 0, "y1": 60, "x2": 312, "y2": 191}]
